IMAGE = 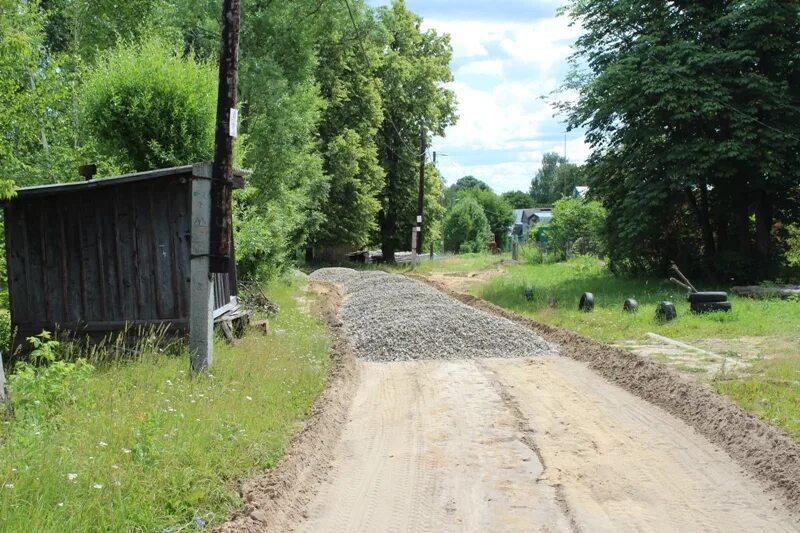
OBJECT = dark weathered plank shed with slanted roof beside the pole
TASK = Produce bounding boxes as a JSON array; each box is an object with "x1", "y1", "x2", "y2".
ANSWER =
[{"x1": 4, "y1": 164, "x2": 244, "y2": 352}]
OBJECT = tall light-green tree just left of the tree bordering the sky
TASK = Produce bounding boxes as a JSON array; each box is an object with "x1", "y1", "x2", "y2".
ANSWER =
[{"x1": 313, "y1": 0, "x2": 384, "y2": 248}]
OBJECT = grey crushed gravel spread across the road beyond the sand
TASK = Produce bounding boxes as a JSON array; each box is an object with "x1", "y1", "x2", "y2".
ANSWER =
[{"x1": 310, "y1": 268, "x2": 554, "y2": 361}]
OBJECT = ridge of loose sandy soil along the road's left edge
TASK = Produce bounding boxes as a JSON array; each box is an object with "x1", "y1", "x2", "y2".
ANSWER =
[{"x1": 215, "y1": 281, "x2": 360, "y2": 533}]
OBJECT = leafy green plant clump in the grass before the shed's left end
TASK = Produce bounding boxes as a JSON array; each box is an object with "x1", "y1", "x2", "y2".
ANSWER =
[{"x1": 8, "y1": 331, "x2": 94, "y2": 423}]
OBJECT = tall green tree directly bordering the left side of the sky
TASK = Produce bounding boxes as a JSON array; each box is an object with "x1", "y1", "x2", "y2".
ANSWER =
[{"x1": 378, "y1": 0, "x2": 456, "y2": 261}]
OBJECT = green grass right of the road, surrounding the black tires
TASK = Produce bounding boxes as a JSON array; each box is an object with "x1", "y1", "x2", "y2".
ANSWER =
[{"x1": 473, "y1": 257, "x2": 800, "y2": 440}]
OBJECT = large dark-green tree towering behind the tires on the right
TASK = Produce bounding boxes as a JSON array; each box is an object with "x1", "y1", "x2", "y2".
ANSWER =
[{"x1": 562, "y1": 0, "x2": 800, "y2": 281}]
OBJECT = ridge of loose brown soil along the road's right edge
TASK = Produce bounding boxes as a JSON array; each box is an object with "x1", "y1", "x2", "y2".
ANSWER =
[{"x1": 406, "y1": 273, "x2": 800, "y2": 521}]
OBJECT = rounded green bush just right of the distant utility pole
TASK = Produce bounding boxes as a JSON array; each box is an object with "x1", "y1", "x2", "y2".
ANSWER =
[{"x1": 443, "y1": 195, "x2": 491, "y2": 253}]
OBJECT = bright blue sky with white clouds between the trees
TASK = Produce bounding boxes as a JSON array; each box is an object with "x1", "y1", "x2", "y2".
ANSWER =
[{"x1": 369, "y1": 0, "x2": 589, "y2": 193}]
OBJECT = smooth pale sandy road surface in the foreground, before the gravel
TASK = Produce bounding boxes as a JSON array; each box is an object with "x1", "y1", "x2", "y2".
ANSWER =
[{"x1": 298, "y1": 357, "x2": 800, "y2": 532}]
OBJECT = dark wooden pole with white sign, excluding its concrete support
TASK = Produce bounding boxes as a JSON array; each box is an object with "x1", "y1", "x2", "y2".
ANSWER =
[{"x1": 209, "y1": 0, "x2": 241, "y2": 272}]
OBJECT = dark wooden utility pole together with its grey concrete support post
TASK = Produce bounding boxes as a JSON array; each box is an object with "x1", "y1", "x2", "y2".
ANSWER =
[{"x1": 189, "y1": 0, "x2": 241, "y2": 374}]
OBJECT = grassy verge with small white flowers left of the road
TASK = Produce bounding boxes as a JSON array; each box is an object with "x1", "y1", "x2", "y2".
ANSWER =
[{"x1": 0, "y1": 276, "x2": 328, "y2": 531}]
